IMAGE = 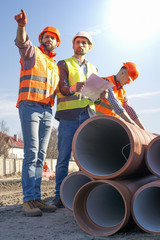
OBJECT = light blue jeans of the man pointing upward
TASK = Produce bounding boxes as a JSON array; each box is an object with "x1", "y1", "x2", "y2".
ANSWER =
[{"x1": 19, "y1": 101, "x2": 53, "y2": 202}]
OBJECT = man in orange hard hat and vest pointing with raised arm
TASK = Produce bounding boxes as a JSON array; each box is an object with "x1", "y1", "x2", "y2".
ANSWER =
[{"x1": 15, "y1": 9, "x2": 61, "y2": 217}]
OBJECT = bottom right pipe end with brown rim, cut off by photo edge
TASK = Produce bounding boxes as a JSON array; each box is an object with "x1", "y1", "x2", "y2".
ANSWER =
[{"x1": 131, "y1": 180, "x2": 160, "y2": 233}]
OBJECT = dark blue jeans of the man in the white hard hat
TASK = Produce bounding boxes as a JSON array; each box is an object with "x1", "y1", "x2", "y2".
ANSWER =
[{"x1": 55, "y1": 112, "x2": 89, "y2": 197}]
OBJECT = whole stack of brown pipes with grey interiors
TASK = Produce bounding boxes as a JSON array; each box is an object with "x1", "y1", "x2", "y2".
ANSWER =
[{"x1": 60, "y1": 115, "x2": 160, "y2": 236}]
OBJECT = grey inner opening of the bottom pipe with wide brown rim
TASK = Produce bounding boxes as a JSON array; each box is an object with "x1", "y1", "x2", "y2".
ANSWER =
[{"x1": 86, "y1": 184, "x2": 125, "y2": 228}]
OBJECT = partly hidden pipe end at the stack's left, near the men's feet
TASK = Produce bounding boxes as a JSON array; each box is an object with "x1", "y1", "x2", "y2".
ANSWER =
[{"x1": 60, "y1": 171, "x2": 93, "y2": 211}]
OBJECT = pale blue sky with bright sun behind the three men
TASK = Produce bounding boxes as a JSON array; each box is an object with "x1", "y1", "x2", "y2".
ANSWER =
[{"x1": 0, "y1": 0, "x2": 160, "y2": 136}]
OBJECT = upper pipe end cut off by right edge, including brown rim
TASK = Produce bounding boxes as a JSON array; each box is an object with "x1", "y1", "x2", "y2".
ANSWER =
[{"x1": 145, "y1": 136, "x2": 160, "y2": 177}]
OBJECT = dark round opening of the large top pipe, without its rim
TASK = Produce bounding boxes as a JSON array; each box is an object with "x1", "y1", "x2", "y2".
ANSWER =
[{"x1": 73, "y1": 119, "x2": 131, "y2": 177}]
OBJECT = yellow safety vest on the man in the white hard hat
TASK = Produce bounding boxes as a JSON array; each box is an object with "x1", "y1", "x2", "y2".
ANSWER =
[{"x1": 57, "y1": 57, "x2": 98, "y2": 111}]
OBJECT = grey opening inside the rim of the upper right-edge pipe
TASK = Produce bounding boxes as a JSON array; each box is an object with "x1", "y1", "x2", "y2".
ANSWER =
[{"x1": 147, "y1": 139, "x2": 160, "y2": 176}]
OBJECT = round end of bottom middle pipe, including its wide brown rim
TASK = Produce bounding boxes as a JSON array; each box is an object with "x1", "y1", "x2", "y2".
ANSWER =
[{"x1": 73, "y1": 180, "x2": 131, "y2": 236}]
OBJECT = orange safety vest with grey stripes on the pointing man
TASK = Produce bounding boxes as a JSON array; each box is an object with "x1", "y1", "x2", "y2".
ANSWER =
[{"x1": 16, "y1": 47, "x2": 59, "y2": 107}]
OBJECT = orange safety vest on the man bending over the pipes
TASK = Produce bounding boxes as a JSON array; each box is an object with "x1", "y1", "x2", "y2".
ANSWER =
[{"x1": 95, "y1": 76, "x2": 126, "y2": 118}]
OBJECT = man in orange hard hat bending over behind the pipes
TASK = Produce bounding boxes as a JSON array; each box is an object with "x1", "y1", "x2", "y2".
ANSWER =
[{"x1": 96, "y1": 62, "x2": 145, "y2": 130}]
